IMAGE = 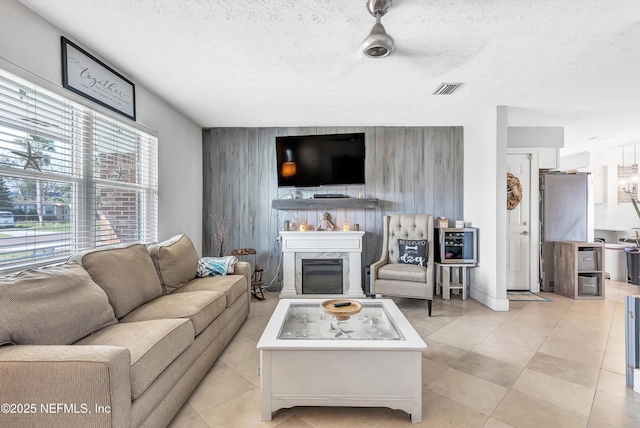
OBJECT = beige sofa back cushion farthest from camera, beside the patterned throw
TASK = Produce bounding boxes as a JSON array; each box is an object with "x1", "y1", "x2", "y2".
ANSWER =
[{"x1": 149, "y1": 234, "x2": 198, "y2": 294}]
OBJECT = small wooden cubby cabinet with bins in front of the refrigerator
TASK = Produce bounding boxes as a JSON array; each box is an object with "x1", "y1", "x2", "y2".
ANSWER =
[{"x1": 553, "y1": 241, "x2": 604, "y2": 299}]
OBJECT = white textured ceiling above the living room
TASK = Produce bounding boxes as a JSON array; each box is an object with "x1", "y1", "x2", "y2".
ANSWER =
[{"x1": 20, "y1": 0, "x2": 640, "y2": 153}]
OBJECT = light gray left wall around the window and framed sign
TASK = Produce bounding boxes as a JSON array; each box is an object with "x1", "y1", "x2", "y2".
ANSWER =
[{"x1": 0, "y1": 0, "x2": 202, "y2": 252}]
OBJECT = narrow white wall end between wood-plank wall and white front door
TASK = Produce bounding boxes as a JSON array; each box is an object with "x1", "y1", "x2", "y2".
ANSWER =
[{"x1": 464, "y1": 107, "x2": 509, "y2": 311}]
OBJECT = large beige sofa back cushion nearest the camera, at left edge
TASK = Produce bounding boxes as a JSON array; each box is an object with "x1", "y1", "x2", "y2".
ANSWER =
[{"x1": 0, "y1": 263, "x2": 117, "y2": 345}]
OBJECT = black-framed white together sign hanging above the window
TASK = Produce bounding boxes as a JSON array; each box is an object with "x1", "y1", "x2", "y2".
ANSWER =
[{"x1": 62, "y1": 37, "x2": 136, "y2": 120}]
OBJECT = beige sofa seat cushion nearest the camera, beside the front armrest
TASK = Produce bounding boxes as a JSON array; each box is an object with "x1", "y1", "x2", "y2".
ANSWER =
[{"x1": 75, "y1": 319, "x2": 194, "y2": 400}]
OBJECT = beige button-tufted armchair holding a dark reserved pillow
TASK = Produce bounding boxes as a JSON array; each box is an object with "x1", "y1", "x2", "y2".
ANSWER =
[{"x1": 371, "y1": 214, "x2": 434, "y2": 316}]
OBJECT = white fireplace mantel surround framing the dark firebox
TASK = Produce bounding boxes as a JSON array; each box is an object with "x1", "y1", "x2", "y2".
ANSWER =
[{"x1": 280, "y1": 231, "x2": 364, "y2": 297}]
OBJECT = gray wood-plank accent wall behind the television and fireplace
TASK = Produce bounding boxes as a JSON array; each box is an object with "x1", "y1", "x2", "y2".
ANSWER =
[{"x1": 202, "y1": 127, "x2": 464, "y2": 290}]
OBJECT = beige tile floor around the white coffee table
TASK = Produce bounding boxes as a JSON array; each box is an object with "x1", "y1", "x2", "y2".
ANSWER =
[{"x1": 171, "y1": 281, "x2": 640, "y2": 428}]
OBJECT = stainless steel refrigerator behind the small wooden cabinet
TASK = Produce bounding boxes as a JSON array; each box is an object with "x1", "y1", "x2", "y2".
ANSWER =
[{"x1": 540, "y1": 172, "x2": 593, "y2": 291}]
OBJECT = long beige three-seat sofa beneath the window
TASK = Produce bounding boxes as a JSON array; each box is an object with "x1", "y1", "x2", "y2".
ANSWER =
[{"x1": 0, "y1": 235, "x2": 251, "y2": 428}]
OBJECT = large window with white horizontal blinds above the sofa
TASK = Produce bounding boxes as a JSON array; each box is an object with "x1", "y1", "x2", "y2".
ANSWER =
[{"x1": 0, "y1": 71, "x2": 158, "y2": 273}]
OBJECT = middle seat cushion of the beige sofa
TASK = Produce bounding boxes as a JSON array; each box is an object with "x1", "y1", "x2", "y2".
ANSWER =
[{"x1": 120, "y1": 291, "x2": 227, "y2": 336}]
